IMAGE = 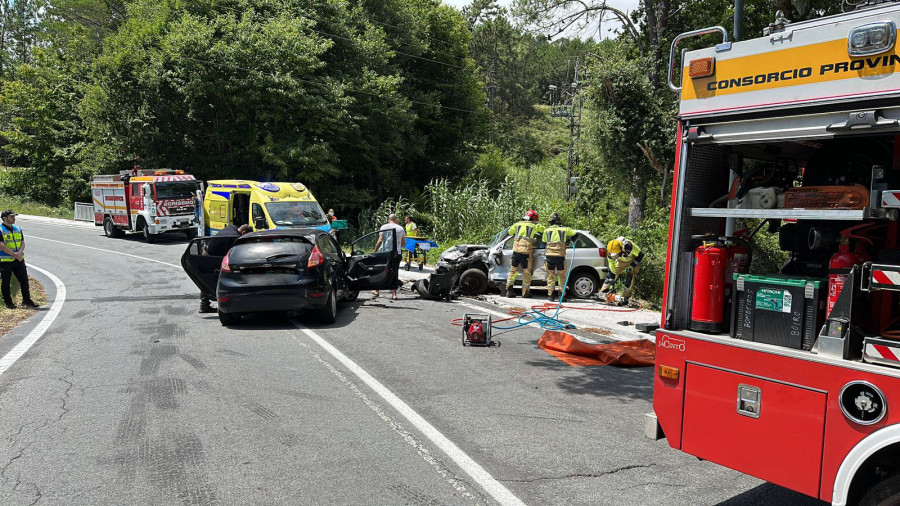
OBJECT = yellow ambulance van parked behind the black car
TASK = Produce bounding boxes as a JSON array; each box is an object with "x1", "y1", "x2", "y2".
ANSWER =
[{"x1": 203, "y1": 179, "x2": 331, "y2": 235}]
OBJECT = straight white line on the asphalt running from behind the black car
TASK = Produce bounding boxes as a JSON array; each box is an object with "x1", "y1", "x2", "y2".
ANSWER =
[{"x1": 293, "y1": 321, "x2": 525, "y2": 506}]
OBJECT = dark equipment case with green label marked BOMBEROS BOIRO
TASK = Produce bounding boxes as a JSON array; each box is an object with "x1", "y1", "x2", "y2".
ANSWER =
[{"x1": 731, "y1": 274, "x2": 825, "y2": 351}]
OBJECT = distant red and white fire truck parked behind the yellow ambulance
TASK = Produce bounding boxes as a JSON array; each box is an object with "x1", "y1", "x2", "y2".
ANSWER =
[{"x1": 91, "y1": 168, "x2": 202, "y2": 242}]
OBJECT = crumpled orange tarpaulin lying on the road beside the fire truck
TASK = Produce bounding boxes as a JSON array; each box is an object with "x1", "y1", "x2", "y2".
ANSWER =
[{"x1": 538, "y1": 330, "x2": 656, "y2": 367}]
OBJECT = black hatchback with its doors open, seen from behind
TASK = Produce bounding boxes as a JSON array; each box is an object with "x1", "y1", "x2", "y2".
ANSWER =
[{"x1": 181, "y1": 228, "x2": 399, "y2": 325}]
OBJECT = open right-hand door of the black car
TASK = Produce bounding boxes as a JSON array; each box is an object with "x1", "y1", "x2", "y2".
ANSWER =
[{"x1": 347, "y1": 228, "x2": 400, "y2": 290}]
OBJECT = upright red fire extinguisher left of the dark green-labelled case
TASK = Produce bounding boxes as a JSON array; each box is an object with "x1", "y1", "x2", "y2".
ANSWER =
[{"x1": 691, "y1": 240, "x2": 728, "y2": 333}]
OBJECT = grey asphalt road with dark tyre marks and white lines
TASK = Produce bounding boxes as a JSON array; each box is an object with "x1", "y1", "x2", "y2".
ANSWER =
[{"x1": 0, "y1": 218, "x2": 819, "y2": 506}]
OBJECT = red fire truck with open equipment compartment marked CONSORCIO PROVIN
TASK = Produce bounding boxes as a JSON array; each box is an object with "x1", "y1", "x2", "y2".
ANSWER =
[{"x1": 653, "y1": 2, "x2": 900, "y2": 505}]
